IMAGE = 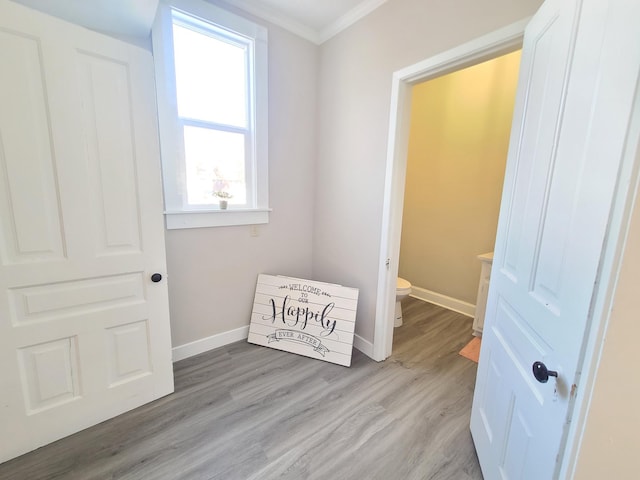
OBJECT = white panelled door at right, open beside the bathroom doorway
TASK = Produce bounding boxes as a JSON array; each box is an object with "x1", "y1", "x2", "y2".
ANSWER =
[{"x1": 471, "y1": 0, "x2": 640, "y2": 480}]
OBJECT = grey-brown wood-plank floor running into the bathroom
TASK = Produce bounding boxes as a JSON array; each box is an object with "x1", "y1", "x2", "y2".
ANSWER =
[{"x1": 0, "y1": 298, "x2": 482, "y2": 480}]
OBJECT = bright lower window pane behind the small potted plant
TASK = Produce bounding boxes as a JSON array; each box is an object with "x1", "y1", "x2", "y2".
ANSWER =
[{"x1": 184, "y1": 126, "x2": 247, "y2": 205}]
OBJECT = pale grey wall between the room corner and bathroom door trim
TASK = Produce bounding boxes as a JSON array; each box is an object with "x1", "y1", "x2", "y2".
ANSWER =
[{"x1": 313, "y1": 0, "x2": 542, "y2": 342}]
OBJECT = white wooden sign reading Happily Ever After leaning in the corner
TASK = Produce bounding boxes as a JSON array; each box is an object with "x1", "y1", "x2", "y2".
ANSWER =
[{"x1": 248, "y1": 274, "x2": 358, "y2": 367}]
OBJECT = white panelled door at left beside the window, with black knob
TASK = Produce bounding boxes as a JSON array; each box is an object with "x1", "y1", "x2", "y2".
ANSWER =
[{"x1": 0, "y1": 0, "x2": 173, "y2": 462}]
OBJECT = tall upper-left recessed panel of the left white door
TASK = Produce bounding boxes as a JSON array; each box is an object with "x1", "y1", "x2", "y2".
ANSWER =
[{"x1": 0, "y1": 30, "x2": 65, "y2": 265}]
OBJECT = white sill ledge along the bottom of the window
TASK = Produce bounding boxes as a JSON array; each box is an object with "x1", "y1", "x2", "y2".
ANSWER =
[{"x1": 164, "y1": 209, "x2": 271, "y2": 230}]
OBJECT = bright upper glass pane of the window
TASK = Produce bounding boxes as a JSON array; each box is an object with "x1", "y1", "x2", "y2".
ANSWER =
[{"x1": 173, "y1": 24, "x2": 247, "y2": 128}]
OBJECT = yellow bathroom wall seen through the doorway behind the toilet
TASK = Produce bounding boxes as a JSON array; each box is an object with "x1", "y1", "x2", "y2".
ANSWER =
[{"x1": 399, "y1": 51, "x2": 520, "y2": 304}]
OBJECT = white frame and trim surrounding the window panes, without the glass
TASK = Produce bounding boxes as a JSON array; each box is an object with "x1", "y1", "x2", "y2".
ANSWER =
[{"x1": 152, "y1": 0, "x2": 271, "y2": 229}]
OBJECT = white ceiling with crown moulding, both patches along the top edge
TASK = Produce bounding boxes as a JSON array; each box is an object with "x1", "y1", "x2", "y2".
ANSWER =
[{"x1": 13, "y1": 0, "x2": 388, "y2": 44}]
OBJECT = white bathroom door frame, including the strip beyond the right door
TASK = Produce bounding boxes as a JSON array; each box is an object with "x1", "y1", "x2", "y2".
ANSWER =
[{"x1": 372, "y1": 13, "x2": 640, "y2": 478}]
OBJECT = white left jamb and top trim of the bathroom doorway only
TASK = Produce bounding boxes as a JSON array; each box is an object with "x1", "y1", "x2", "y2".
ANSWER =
[{"x1": 373, "y1": 20, "x2": 528, "y2": 361}]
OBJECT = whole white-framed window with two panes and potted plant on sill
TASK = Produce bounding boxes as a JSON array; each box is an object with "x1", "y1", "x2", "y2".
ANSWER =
[{"x1": 153, "y1": 0, "x2": 269, "y2": 229}]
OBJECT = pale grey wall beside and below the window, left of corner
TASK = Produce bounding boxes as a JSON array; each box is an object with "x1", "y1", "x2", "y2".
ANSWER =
[{"x1": 166, "y1": 2, "x2": 318, "y2": 348}]
